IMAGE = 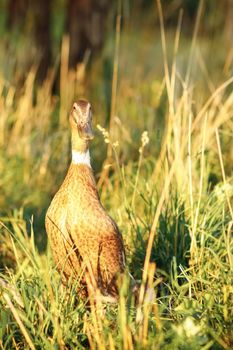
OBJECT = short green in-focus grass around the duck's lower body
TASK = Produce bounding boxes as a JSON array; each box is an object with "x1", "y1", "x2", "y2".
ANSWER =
[{"x1": 0, "y1": 178, "x2": 233, "y2": 349}]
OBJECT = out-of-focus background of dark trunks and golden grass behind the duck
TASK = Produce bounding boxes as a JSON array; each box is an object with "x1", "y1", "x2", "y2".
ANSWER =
[{"x1": 0, "y1": 0, "x2": 233, "y2": 249}]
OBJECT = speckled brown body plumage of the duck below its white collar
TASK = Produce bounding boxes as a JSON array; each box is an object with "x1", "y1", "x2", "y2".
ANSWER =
[{"x1": 45, "y1": 100, "x2": 125, "y2": 296}]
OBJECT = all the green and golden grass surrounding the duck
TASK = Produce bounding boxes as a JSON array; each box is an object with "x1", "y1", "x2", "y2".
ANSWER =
[{"x1": 0, "y1": 2, "x2": 233, "y2": 350}]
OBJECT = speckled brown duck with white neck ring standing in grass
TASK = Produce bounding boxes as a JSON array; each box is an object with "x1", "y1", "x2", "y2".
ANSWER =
[{"x1": 45, "y1": 99, "x2": 125, "y2": 301}]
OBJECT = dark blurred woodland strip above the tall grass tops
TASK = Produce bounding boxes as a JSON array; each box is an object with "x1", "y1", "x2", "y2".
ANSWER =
[{"x1": 0, "y1": 0, "x2": 233, "y2": 83}]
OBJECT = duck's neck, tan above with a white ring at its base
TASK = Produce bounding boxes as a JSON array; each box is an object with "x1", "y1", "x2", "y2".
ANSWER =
[{"x1": 71, "y1": 131, "x2": 91, "y2": 167}]
